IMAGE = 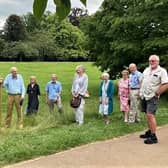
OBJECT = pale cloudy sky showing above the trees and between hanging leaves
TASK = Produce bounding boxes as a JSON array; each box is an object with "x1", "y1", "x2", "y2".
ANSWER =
[{"x1": 0, "y1": 0, "x2": 103, "y2": 29}]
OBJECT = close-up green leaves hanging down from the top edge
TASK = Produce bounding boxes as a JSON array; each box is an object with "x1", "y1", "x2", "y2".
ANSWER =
[{"x1": 33, "y1": 0, "x2": 86, "y2": 20}]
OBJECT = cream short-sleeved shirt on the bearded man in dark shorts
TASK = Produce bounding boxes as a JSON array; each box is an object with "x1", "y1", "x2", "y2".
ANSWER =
[{"x1": 140, "y1": 66, "x2": 168, "y2": 100}]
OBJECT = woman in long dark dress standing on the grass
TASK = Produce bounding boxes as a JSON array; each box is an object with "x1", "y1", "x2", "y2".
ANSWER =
[{"x1": 26, "y1": 76, "x2": 40, "y2": 115}]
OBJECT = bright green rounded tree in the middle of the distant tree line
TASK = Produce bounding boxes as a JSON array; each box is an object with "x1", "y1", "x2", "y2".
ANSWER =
[{"x1": 55, "y1": 21, "x2": 88, "y2": 60}]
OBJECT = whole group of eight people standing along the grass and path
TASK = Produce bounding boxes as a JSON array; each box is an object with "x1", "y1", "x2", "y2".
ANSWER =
[{"x1": 3, "y1": 55, "x2": 168, "y2": 144}]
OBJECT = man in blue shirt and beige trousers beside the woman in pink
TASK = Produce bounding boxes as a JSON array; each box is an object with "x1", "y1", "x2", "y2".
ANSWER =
[{"x1": 128, "y1": 63, "x2": 142, "y2": 123}]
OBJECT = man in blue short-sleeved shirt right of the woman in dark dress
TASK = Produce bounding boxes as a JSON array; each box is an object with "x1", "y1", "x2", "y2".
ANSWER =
[{"x1": 45, "y1": 74, "x2": 62, "y2": 112}]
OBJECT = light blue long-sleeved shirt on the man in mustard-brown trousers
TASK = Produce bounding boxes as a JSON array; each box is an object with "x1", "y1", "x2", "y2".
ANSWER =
[{"x1": 3, "y1": 74, "x2": 25, "y2": 98}]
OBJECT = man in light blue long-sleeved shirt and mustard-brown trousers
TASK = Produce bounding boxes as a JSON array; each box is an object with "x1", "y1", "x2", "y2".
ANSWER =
[{"x1": 3, "y1": 67, "x2": 25, "y2": 129}]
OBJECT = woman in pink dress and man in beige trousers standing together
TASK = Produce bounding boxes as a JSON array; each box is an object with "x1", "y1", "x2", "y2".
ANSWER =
[{"x1": 118, "y1": 63, "x2": 142, "y2": 123}]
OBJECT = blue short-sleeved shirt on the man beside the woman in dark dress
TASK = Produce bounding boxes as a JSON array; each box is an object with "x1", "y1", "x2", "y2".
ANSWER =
[{"x1": 45, "y1": 81, "x2": 62, "y2": 100}]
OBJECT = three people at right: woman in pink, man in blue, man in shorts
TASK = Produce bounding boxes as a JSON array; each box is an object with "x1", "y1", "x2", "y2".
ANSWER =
[{"x1": 118, "y1": 55, "x2": 168, "y2": 144}]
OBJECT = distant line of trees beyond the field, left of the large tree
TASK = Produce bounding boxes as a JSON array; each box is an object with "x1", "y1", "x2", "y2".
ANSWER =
[{"x1": 0, "y1": 12, "x2": 89, "y2": 61}]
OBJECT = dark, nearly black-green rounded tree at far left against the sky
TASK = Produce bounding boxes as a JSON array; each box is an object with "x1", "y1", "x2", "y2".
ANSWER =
[{"x1": 4, "y1": 15, "x2": 26, "y2": 41}]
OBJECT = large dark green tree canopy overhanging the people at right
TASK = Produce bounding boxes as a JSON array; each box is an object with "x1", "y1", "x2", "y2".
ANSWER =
[{"x1": 81, "y1": 0, "x2": 168, "y2": 77}]
